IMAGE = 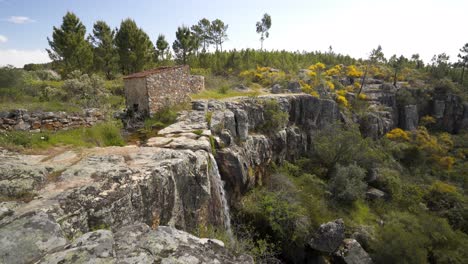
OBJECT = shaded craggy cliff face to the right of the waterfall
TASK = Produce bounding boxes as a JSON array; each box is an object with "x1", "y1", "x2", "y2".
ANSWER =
[{"x1": 194, "y1": 95, "x2": 340, "y2": 199}]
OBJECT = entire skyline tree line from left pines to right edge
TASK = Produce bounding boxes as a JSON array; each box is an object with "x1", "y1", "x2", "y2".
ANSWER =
[{"x1": 47, "y1": 12, "x2": 468, "y2": 85}]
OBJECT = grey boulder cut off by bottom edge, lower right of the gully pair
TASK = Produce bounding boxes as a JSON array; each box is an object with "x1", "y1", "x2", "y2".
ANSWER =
[{"x1": 334, "y1": 239, "x2": 373, "y2": 264}]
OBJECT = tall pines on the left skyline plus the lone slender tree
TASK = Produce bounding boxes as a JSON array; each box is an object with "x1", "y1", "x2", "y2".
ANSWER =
[{"x1": 47, "y1": 12, "x2": 271, "y2": 79}]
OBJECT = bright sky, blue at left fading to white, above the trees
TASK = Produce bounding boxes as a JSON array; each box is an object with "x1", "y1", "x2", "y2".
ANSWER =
[{"x1": 0, "y1": 0, "x2": 468, "y2": 67}]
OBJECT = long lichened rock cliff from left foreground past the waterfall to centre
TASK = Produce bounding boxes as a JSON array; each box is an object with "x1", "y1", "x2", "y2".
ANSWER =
[{"x1": 0, "y1": 95, "x2": 339, "y2": 263}]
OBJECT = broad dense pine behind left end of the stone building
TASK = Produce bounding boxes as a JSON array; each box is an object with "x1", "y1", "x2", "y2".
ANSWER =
[{"x1": 115, "y1": 18, "x2": 155, "y2": 74}]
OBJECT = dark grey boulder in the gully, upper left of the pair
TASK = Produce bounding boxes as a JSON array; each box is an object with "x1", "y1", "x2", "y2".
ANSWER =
[{"x1": 309, "y1": 219, "x2": 345, "y2": 253}]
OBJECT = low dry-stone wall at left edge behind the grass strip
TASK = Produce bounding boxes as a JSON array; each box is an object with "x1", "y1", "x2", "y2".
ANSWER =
[{"x1": 0, "y1": 109, "x2": 105, "y2": 132}]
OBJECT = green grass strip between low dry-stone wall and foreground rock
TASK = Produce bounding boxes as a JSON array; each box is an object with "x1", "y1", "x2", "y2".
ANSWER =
[{"x1": 0, "y1": 122, "x2": 125, "y2": 150}]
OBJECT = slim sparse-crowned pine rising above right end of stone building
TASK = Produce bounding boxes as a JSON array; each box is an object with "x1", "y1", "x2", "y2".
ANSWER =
[{"x1": 172, "y1": 26, "x2": 199, "y2": 64}]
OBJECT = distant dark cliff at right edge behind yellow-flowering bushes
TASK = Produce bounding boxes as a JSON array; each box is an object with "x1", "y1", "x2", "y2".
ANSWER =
[{"x1": 354, "y1": 83, "x2": 468, "y2": 139}]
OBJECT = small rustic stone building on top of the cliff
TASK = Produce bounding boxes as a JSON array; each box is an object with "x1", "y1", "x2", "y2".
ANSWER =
[{"x1": 123, "y1": 65, "x2": 205, "y2": 116}]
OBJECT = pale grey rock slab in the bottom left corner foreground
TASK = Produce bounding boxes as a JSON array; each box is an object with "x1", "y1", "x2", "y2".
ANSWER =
[{"x1": 0, "y1": 212, "x2": 67, "y2": 264}]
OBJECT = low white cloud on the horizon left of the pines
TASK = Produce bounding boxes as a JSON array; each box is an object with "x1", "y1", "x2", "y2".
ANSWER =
[{"x1": 0, "y1": 49, "x2": 50, "y2": 67}]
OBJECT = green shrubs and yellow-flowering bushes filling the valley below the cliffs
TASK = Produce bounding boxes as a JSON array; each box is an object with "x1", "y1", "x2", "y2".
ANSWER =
[{"x1": 234, "y1": 125, "x2": 468, "y2": 263}]
